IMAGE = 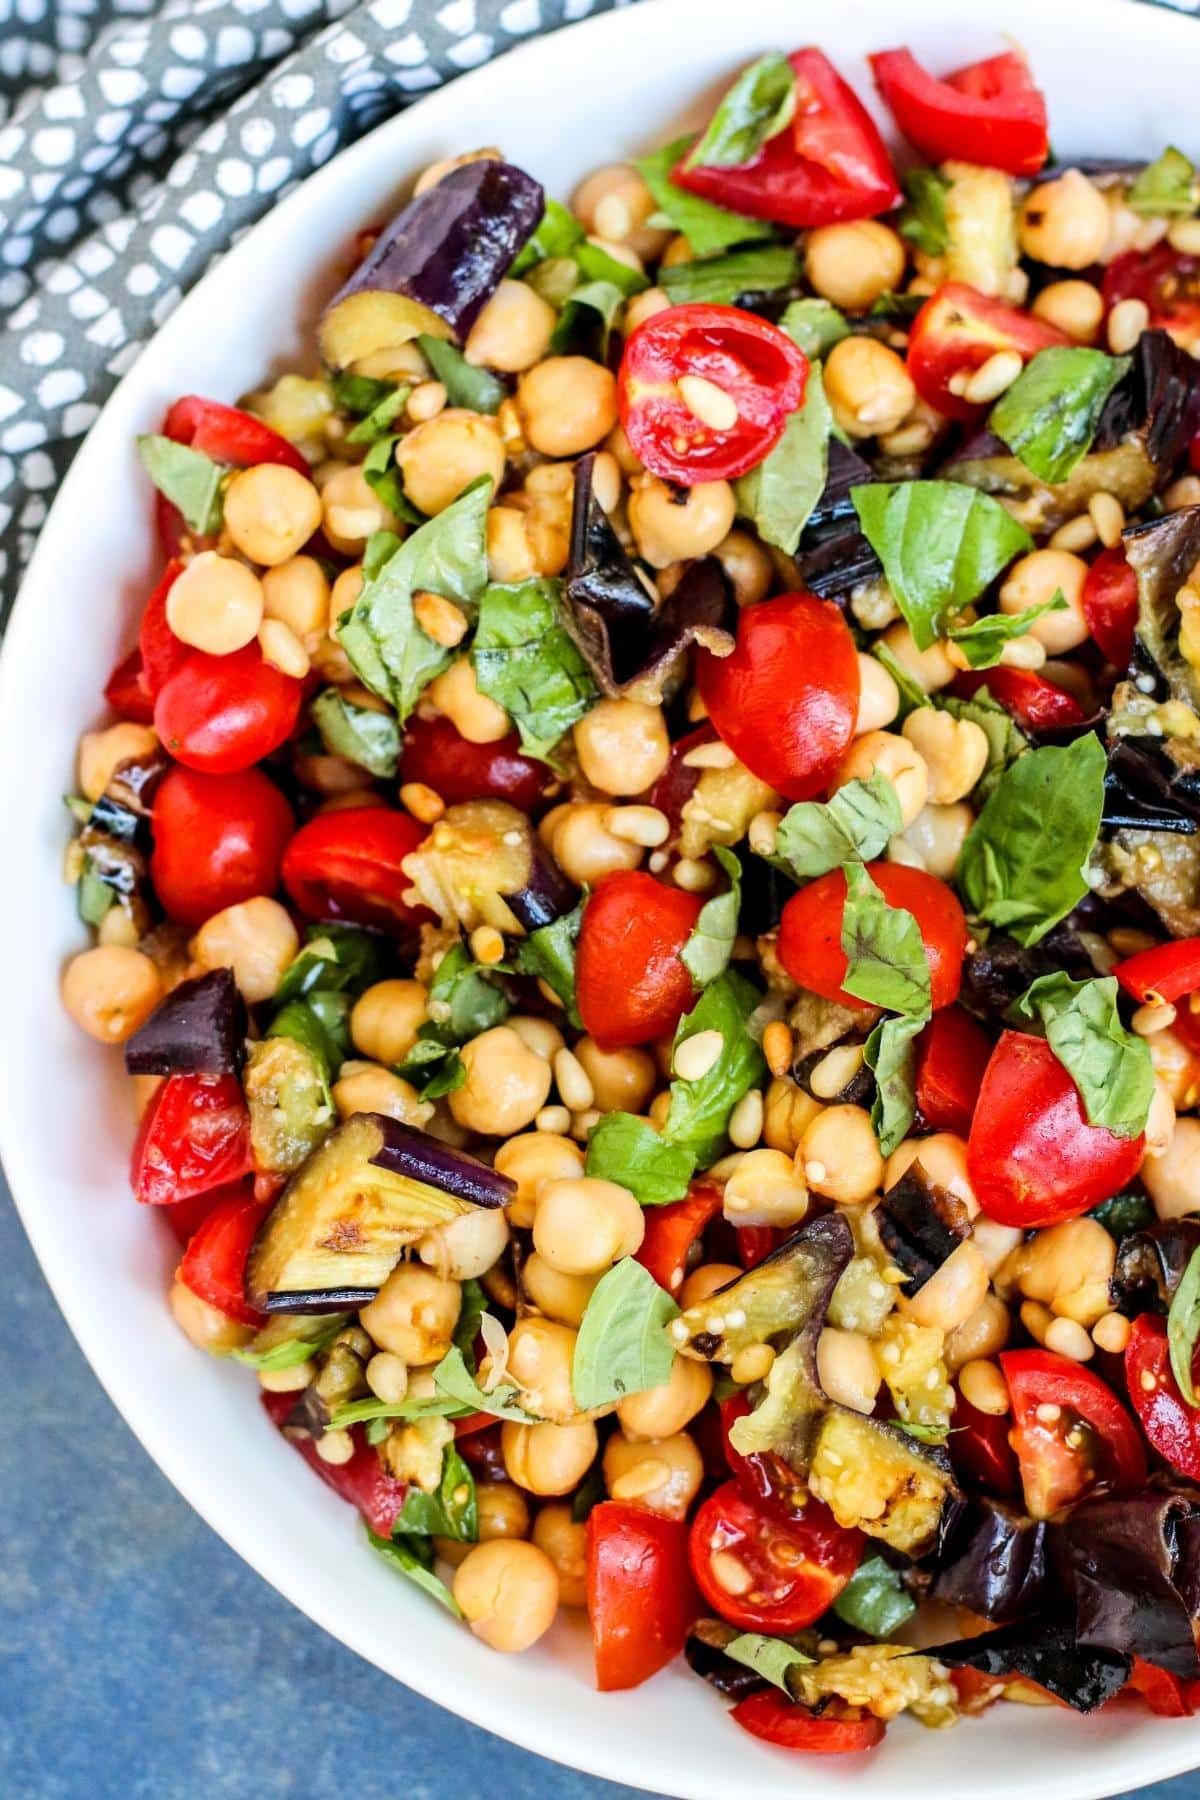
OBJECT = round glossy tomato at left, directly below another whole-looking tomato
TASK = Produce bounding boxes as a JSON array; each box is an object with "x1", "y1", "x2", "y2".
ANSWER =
[{"x1": 149, "y1": 767, "x2": 295, "y2": 925}]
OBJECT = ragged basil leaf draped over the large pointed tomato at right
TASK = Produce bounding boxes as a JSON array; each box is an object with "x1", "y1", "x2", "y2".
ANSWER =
[{"x1": 1007, "y1": 970, "x2": 1155, "y2": 1138}]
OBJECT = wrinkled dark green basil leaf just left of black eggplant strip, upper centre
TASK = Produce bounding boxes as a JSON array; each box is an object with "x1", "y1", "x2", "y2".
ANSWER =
[{"x1": 471, "y1": 576, "x2": 599, "y2": 765}]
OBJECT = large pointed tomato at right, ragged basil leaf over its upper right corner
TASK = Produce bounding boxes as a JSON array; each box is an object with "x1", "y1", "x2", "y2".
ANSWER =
[{"x1": 966, "y1": 1031, "x2": 1146, "y2": 1228}]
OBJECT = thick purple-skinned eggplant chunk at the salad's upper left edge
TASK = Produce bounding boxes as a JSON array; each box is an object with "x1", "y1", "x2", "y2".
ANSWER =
[{"x1": 320, "y1": 158, "x2": 545, "y2": 369}]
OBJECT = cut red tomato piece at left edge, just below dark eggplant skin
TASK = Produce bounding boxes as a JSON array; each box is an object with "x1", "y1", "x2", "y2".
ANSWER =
[{"x1": 130, "y1": 1075, "x2": 252, "y2": 1206}]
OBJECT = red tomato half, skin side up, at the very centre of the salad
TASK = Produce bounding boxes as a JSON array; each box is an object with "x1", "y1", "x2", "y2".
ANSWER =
[{"x1": 576, "y1": 869, "x2": 702, "y2": 1049}]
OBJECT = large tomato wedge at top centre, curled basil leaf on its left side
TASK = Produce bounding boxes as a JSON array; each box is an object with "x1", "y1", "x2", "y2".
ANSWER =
[{"x1": 671, "y1": 49, "x2": 900, "y2": 229}]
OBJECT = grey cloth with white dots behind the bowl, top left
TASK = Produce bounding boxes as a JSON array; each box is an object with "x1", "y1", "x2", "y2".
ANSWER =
[{"x1": 0, "y1": 0, "x2": 631, "y2": 628}]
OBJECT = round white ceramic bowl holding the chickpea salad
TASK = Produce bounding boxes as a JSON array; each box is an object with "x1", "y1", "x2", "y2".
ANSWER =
[{"x1": 0, "y1": 0, "x2": 1200, "y2": 1800}]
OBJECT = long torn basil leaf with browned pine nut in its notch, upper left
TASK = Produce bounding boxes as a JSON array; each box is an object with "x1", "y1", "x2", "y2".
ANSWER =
[{"x1": 338, "y1": 475, "x2": 491, "y2": 724}]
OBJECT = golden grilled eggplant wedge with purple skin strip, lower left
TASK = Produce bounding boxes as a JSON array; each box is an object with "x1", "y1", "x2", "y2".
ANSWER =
[{"x1": 245, "y1": 1112, "x2": 515, "y2": 1312}]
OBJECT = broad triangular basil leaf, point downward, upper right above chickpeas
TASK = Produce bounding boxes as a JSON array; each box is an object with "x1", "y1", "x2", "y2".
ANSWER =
[{"x1": 851, "y1": 481, "x2": 1033, "y2": 650}]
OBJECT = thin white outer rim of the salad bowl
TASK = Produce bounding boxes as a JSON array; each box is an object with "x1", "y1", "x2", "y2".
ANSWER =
[{"x1": 0, "y1": 0, "x2": 1200, "y2": 1800}]
